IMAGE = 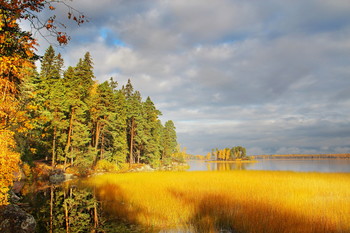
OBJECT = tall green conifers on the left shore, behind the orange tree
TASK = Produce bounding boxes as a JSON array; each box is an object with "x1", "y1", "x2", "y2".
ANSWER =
[{"x1": 16, "y1": 46, "x2": 177, "y2": 170}]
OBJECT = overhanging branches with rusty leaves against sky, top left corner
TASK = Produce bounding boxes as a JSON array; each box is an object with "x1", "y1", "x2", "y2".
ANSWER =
[{"x1": 0, "y1": 0, "x2": 88, "y2": 45}]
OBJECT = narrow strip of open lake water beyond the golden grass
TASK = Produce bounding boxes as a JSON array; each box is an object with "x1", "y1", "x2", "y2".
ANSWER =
[{"x1": 188, "y1": 159, "x2": 350, "y2": 172}]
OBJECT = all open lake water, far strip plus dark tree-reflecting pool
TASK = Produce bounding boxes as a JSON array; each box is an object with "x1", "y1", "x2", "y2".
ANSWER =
[{"x1": 22, "y1": 159, "x2": 350, "y2": 233}]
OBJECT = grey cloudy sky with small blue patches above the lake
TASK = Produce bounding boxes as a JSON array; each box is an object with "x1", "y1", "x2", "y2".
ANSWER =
[{"x1": 33, "y1": 0, "x2": 350, "y2": 155}]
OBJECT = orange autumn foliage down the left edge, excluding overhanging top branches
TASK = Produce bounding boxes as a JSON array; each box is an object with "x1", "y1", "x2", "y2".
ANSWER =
[{"x1": 0, "y1": 7, "x2": 35, "y2": 204}]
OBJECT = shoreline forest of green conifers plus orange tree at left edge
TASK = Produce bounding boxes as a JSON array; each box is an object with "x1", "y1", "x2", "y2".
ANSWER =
[{"x1": 0, "y1": 0, "x2": 181, "y2": 205}]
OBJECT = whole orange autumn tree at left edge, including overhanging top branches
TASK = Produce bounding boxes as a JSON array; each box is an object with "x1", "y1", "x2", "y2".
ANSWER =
[{"x1": 0, "y1": 0, "x2": 85, "y2": 204}]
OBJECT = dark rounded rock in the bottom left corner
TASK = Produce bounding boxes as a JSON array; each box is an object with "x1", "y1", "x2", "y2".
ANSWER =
[{"x1": 0, "y1": 205, "x2": 36, "y2": 233}]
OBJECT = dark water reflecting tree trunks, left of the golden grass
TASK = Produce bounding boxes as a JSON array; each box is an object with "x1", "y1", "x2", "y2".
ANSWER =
[{"x1": 21, "y1": 184, "x2": 144, "y2": 232}]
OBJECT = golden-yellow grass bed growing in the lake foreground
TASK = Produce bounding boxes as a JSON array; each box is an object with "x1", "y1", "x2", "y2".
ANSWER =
[{"x1": 88, "y1": 171, "x2": 350, "y2": 233}]
